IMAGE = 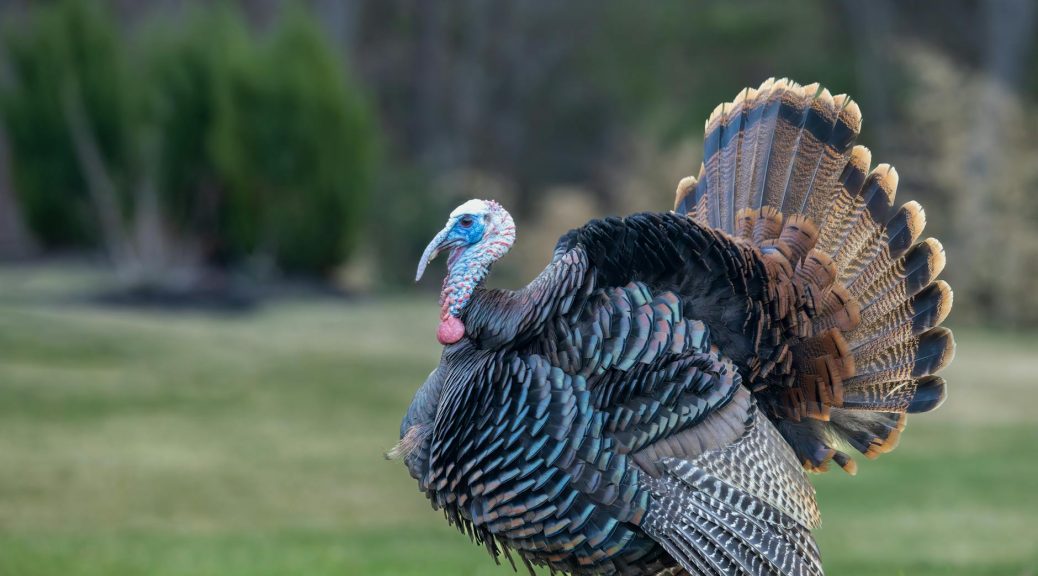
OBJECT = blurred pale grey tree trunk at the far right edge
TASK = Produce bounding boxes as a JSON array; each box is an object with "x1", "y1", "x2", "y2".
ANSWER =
[{"x1": 955, "y1": 0, "x2": 1035, "y2": 324}]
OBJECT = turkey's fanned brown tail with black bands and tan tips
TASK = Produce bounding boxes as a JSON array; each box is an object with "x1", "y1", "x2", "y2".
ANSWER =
[{"x1": 675, "y1": 79, "x2": 955, "y2": 472}]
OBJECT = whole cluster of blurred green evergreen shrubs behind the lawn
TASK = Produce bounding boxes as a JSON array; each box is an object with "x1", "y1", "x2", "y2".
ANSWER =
[{"x1": 2, "y1": 0, "x2": 377, "y2": 274}]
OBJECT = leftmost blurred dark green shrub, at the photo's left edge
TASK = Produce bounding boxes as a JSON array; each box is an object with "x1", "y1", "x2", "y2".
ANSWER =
[{"x1": 0, "y1": 2, "x2": 131, "y2": 247}]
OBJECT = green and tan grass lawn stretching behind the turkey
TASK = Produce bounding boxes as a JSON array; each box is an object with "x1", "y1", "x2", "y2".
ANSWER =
[{"x1": 0, "y1": 268, "x2": 1038, "y2": 576}]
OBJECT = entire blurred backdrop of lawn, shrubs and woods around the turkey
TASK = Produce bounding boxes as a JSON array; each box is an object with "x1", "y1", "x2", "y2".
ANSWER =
[{"x1": 0, "y1": 0, "x2": 1038, "y2": 575}]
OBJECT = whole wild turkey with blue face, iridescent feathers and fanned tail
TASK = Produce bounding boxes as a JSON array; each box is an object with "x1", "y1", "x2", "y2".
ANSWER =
[{"x1": 392, "y1": 80, "x2": 954, "y2": 575}]
